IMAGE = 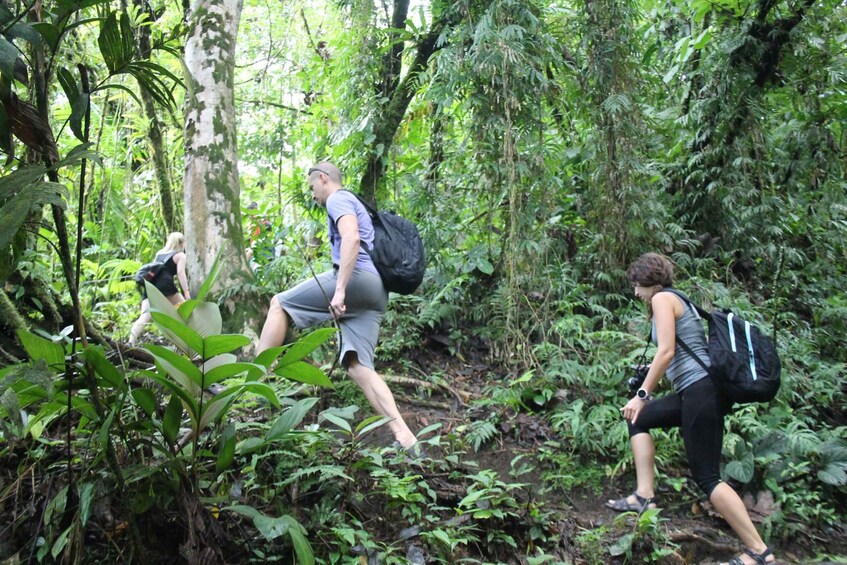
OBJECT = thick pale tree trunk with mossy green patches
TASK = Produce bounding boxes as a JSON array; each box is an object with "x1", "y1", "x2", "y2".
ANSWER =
[{"x1": 185, "y1": 0, "x2": 258, "y2": 334}]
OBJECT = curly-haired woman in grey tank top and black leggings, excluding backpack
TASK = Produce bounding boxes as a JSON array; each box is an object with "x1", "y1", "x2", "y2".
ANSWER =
[{"x1": 606, "y1": 253, "x2": 776, "y2": 565}]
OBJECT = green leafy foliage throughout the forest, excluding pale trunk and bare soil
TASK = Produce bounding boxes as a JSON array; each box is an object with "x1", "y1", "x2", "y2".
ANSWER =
[{"x1": 0, "y1": 0, "x2": 847, "y2": 563}]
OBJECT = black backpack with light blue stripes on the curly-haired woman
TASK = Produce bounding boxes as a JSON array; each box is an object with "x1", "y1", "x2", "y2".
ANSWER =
[{"x1": 664, "y1": 288, "x2": 782, "y2": 404}]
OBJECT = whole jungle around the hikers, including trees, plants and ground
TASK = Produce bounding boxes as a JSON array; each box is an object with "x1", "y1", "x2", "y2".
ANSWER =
[{"x1": 0, "y1": 0, "x2": 847, "y2": 564}]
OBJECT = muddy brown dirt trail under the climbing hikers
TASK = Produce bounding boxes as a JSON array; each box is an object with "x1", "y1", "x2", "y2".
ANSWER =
[{"x1": 386, "y1": 351, "x2": 847, "y2": 565}]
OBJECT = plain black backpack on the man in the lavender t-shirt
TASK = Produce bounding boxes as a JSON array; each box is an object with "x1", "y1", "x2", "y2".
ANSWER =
[{"x1": 342, "y1": 192, "x2": 426, "y2": 294}]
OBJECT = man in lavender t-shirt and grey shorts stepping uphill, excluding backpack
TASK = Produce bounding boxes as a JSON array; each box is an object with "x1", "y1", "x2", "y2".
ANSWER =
[{"x1": 258, "y1": 162, "x2": 421, "y2": 455}]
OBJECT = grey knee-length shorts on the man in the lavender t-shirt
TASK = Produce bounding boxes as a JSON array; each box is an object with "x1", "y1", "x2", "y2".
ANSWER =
[{"x1": 276, "y1": 269, "x2": 388, "y2": 369}]
